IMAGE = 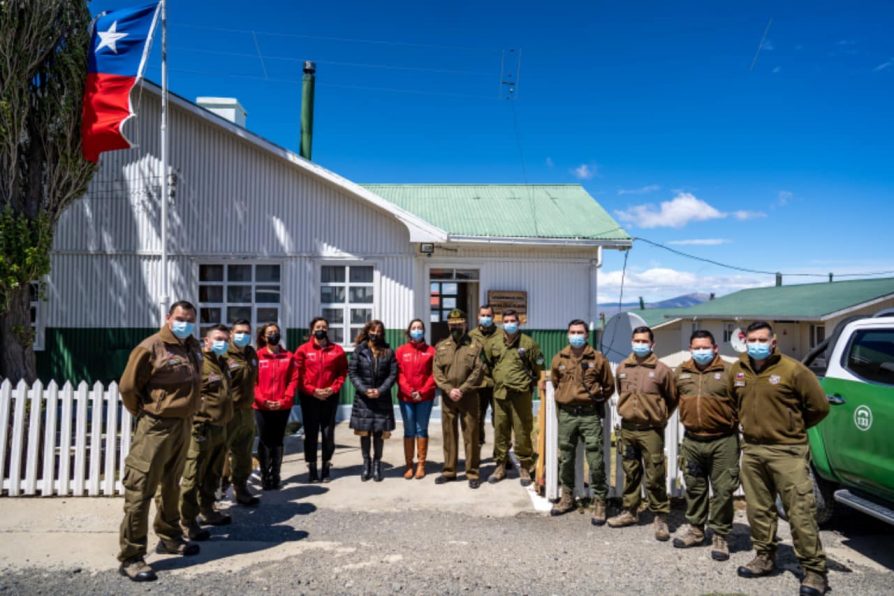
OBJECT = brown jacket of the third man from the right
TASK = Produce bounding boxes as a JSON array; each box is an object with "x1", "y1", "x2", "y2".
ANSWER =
[{"x1": 615, "y1": 354, "x2": 677, "y2": 429}]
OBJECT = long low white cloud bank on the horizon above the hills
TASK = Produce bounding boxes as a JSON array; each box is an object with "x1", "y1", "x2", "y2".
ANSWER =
[{"x1": 598, "y1": 267, "x2": 775, "y2": 303}]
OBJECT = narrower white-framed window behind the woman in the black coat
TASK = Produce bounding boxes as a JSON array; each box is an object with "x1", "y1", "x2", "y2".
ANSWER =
[{"x1": 320, "y1": 265, "x2": 375, "y2": 345}]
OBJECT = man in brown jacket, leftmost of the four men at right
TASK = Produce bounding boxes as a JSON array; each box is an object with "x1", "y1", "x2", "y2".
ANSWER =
[{"x1": 550, "y1": 319, "x2": 615, "y2": 526}]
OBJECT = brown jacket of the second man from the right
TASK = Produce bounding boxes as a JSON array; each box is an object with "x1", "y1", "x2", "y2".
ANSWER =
[{"x1": 674, "y1": 356, "x2": 738, "y2": 439}]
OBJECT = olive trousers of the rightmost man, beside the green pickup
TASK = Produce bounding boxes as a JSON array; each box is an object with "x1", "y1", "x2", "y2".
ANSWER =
[{"x1": 742, "y1": 444, "x2": 826, "y2": 574}]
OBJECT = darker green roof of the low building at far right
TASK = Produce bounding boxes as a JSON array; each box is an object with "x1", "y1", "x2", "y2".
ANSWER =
[{"x1": 673, "y1": 277, "x2": 894, "y2": 320}]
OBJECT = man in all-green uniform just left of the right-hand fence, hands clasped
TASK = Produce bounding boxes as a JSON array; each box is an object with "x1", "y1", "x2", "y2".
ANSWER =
[{"x1": 484, "y1": 309, "x2": 543, "y2": 486}]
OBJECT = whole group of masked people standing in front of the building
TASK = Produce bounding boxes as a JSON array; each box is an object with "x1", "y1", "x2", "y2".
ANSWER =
[{"x1": 118, "y1": 301, "x2": 829, "y2": 596}]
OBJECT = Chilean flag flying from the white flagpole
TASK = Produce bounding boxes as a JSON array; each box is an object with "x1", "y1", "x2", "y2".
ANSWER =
[{"x1": 81, "y1": 1, "x2": 160, "y2": 163}]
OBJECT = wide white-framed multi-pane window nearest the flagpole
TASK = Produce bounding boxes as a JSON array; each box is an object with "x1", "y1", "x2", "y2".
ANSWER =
[{"x1": 199, "y1": 263, "x2": 281, "y2": 335}]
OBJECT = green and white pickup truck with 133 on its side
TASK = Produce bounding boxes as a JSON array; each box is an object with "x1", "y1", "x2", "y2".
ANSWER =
[{"x1": 804, "y1": 312, "x2": 894, "y2": 524}]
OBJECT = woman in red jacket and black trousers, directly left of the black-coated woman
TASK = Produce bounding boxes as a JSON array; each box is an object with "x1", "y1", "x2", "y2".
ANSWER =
[{"x1": 295, "y1": 317, "x2": 348, "y2": 482}]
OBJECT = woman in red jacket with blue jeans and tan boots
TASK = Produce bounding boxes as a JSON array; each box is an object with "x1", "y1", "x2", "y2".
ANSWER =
[{"x1": 397, "y1": 319, "x2": 435, "y2": 480}]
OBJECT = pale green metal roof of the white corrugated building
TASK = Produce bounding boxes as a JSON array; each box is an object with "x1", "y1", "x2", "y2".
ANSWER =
[{"x1": 362, "y1": 184, "x2": 630, "y2": 242}]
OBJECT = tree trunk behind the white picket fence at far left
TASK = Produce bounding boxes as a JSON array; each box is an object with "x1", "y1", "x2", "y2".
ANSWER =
[{"x1": 0, "y1": 286, "x2": 37, "y2": 383}]
